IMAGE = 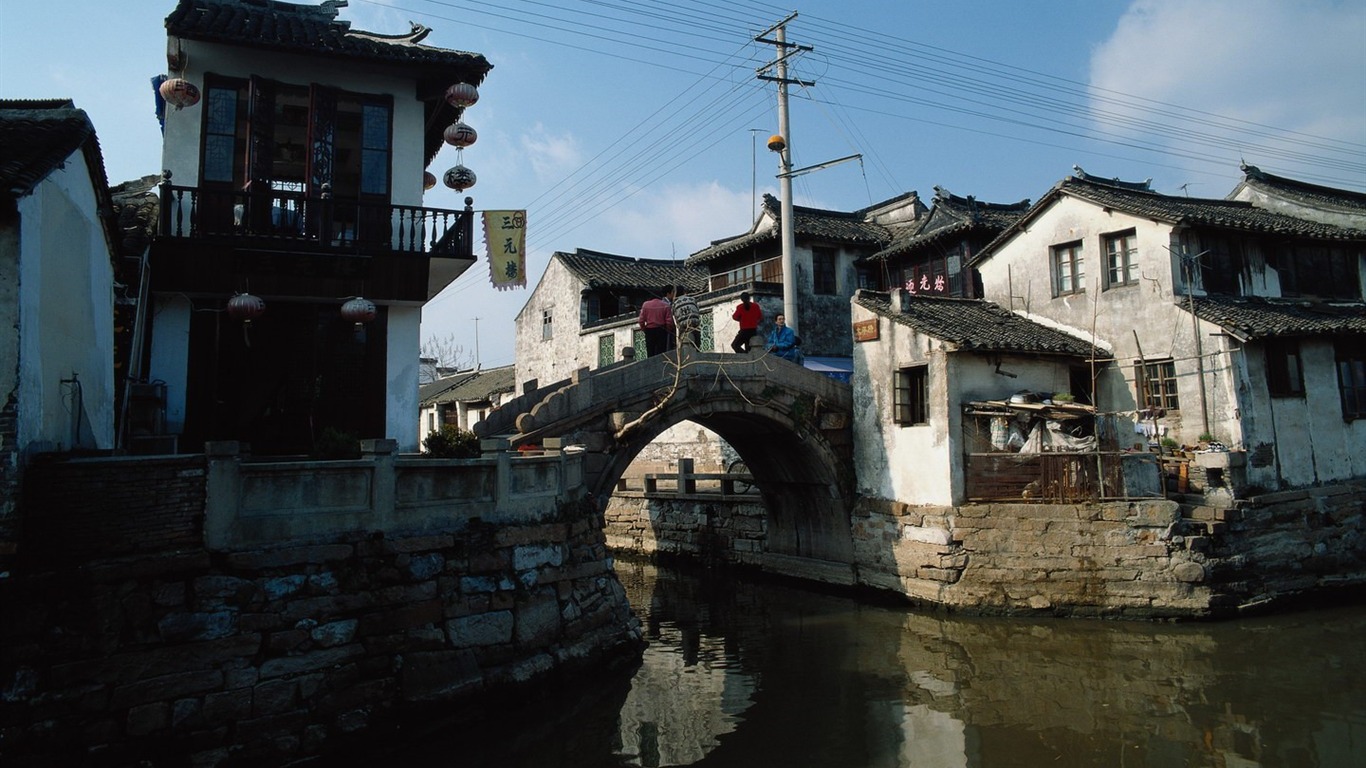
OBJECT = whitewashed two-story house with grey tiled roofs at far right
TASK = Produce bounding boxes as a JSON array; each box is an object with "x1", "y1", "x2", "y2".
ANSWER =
[{"x1": 974, "y1": 169, "x2": 1366, "y2": 488}]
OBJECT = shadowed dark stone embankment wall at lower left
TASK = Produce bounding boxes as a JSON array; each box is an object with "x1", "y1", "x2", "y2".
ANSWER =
[{"x1": 0, "y1": 456, "x2": 641, "y2": 767}]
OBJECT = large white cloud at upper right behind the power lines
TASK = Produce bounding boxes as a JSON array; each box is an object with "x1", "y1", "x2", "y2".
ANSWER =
[{"x1": 1090, "y1": 0, "x2": 1366, "y2": 187}]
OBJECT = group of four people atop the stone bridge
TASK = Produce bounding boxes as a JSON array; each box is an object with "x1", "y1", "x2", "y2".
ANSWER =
[{"x1": 637, "y1": 286, "x2": 802, "y2": 365}]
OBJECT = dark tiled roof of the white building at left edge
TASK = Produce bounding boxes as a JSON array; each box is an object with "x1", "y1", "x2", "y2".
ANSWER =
[{"x1": 0, "y1": 98, "x2": 101, "y2": 197}]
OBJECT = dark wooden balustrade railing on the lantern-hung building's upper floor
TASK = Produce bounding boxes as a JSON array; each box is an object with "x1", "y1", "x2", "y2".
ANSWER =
[{"x1": 160, "y1": 180, "x2": 474, "y2": 258}]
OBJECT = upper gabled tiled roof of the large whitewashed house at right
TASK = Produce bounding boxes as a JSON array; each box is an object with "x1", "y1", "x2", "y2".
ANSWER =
[{"x1": 974, "y1": 175, "x2": 1366, "y2": 261}]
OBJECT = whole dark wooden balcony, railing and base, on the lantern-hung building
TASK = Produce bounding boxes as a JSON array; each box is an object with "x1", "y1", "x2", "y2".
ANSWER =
[{"x1": 152, "y1": 180, "x2": 474, "y2": 302}]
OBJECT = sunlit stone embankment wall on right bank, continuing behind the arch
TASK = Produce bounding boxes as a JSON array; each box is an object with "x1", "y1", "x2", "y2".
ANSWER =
[{"x1": 607, "y1": 482, "x2": 1366, "y2": 618}]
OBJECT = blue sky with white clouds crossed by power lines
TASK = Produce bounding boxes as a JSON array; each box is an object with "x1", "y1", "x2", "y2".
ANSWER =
[{"x1": 0, "y1": 0, "x2": 1366, "y2": 368}]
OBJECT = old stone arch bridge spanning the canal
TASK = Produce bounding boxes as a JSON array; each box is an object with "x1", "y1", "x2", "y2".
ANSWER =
[{"x1": 475, "y1": 347, "x2": 854, "y2": 571}]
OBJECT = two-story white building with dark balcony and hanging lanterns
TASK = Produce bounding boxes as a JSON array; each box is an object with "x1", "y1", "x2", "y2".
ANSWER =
[{"x1": 146, "y1": 0, "x2": 490, "y2": 454}]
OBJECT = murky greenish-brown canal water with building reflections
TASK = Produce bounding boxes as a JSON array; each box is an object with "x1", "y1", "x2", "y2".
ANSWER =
[{"x1": 372, "y1": 554, "x2": 1366, "y2": 768}]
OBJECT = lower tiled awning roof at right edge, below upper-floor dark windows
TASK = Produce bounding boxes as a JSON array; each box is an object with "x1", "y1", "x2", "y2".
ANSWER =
[{"x1": 1177, "y1": 297, "x2": 1366, "y2": 340}]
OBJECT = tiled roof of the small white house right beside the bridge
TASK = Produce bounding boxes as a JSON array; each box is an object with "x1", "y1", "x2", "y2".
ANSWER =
[{"x1": 854, "y1": 290, "x2": 1111, "y2": 359}]
